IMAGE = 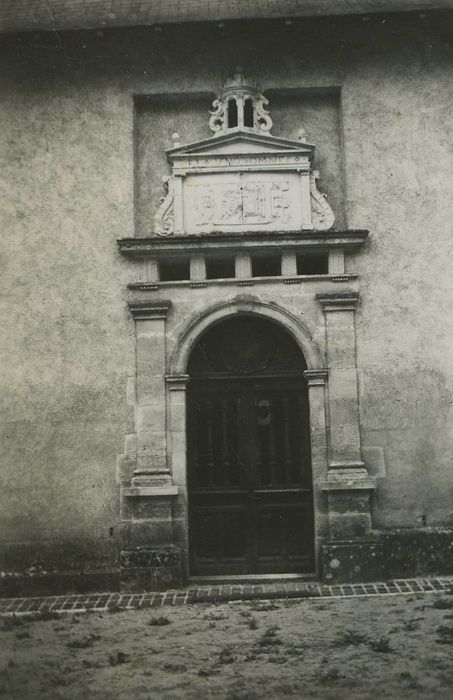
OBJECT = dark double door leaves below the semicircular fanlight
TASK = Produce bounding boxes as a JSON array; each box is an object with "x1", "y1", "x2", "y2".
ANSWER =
[{"x1": 188, "y1": 377, "x2": 314, "y2": 575}]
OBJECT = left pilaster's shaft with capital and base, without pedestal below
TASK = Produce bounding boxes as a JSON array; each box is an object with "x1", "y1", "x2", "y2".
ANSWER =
[{"x1": 129, "y1": 301, "x2": 171, "y2": 487}]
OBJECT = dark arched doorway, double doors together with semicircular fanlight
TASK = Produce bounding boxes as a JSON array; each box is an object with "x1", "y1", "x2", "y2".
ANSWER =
[{"x1": 187, "y1": 315, "x2": 315, "y2": 576}]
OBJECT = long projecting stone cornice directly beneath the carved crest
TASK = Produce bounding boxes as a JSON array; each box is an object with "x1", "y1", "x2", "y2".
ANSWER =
[{"x1": 117, "y1": 229, "x2": 368, "y2": 259}]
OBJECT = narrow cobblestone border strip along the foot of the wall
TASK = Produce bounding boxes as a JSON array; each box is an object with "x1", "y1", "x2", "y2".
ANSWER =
[{"x1": 0, "y1": 576, "x2": 453, "y2": 617}]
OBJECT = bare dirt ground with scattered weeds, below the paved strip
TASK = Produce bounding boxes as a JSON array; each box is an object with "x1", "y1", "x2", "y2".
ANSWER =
[{"x1": 0, "y1": 594, "x2": 453, "y2": 700}]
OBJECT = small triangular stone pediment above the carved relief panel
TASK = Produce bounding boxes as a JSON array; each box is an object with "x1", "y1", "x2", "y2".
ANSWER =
[{"x1": 167, "y1": 129, "x2": 315, "y2": 161}]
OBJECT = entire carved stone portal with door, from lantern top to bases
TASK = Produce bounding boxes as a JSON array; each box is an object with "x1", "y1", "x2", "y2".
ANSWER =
[{"x1": 119, "y1": 71, "x2": 379, "y2": 587}]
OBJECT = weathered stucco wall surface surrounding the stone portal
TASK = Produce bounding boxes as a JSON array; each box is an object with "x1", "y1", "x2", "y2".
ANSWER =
[{"x1": 0, "y1": 15, "x2": 453, "y2": 580}]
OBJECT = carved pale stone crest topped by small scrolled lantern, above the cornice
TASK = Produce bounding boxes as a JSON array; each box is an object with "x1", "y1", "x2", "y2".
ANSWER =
[{"x1": 154, "y1": 68, "x2": 335, "y2": 236}]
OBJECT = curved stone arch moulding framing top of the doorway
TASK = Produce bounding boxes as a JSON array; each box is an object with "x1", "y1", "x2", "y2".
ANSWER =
[{"x1": 170, "y1": 298, "x2": 323, "y2": 375}]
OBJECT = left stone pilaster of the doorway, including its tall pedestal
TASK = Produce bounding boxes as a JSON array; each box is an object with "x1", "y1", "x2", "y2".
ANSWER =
[{"x1": 122, "y1": 301, "x2": 182, "y2": 568}]
